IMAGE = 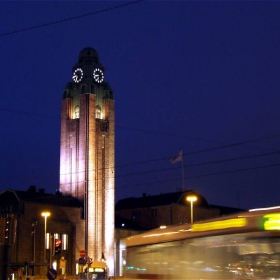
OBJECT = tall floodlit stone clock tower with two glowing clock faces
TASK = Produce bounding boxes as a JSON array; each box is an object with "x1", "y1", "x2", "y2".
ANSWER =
[{"x1": 60, "y1": 48, "x2": 115, "y2": 272}]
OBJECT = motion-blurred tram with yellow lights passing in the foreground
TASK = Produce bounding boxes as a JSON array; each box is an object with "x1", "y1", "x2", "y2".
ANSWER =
[{"x1": 123, "y1": 207, "x2": 280, "y2": 280}]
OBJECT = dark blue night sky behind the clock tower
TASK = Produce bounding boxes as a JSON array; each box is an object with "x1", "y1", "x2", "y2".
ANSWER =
[{"x1": 0, "y1": 1, "x2": 280, "y2": 208}]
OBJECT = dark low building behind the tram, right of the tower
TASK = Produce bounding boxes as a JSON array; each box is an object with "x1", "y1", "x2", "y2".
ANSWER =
[{"x1": 115, "y1": 190, "x2": 220, "y2": 229}]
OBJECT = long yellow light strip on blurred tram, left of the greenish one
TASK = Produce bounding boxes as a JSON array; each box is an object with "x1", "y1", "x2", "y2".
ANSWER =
[{"x1": 191, "y1": 218, "x2": 247, "y2": 231}]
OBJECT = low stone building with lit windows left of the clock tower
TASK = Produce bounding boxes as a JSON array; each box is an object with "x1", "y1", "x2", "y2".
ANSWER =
[{"x1": 0, "y1": 186, "x2": 84, "y2": 279}]
